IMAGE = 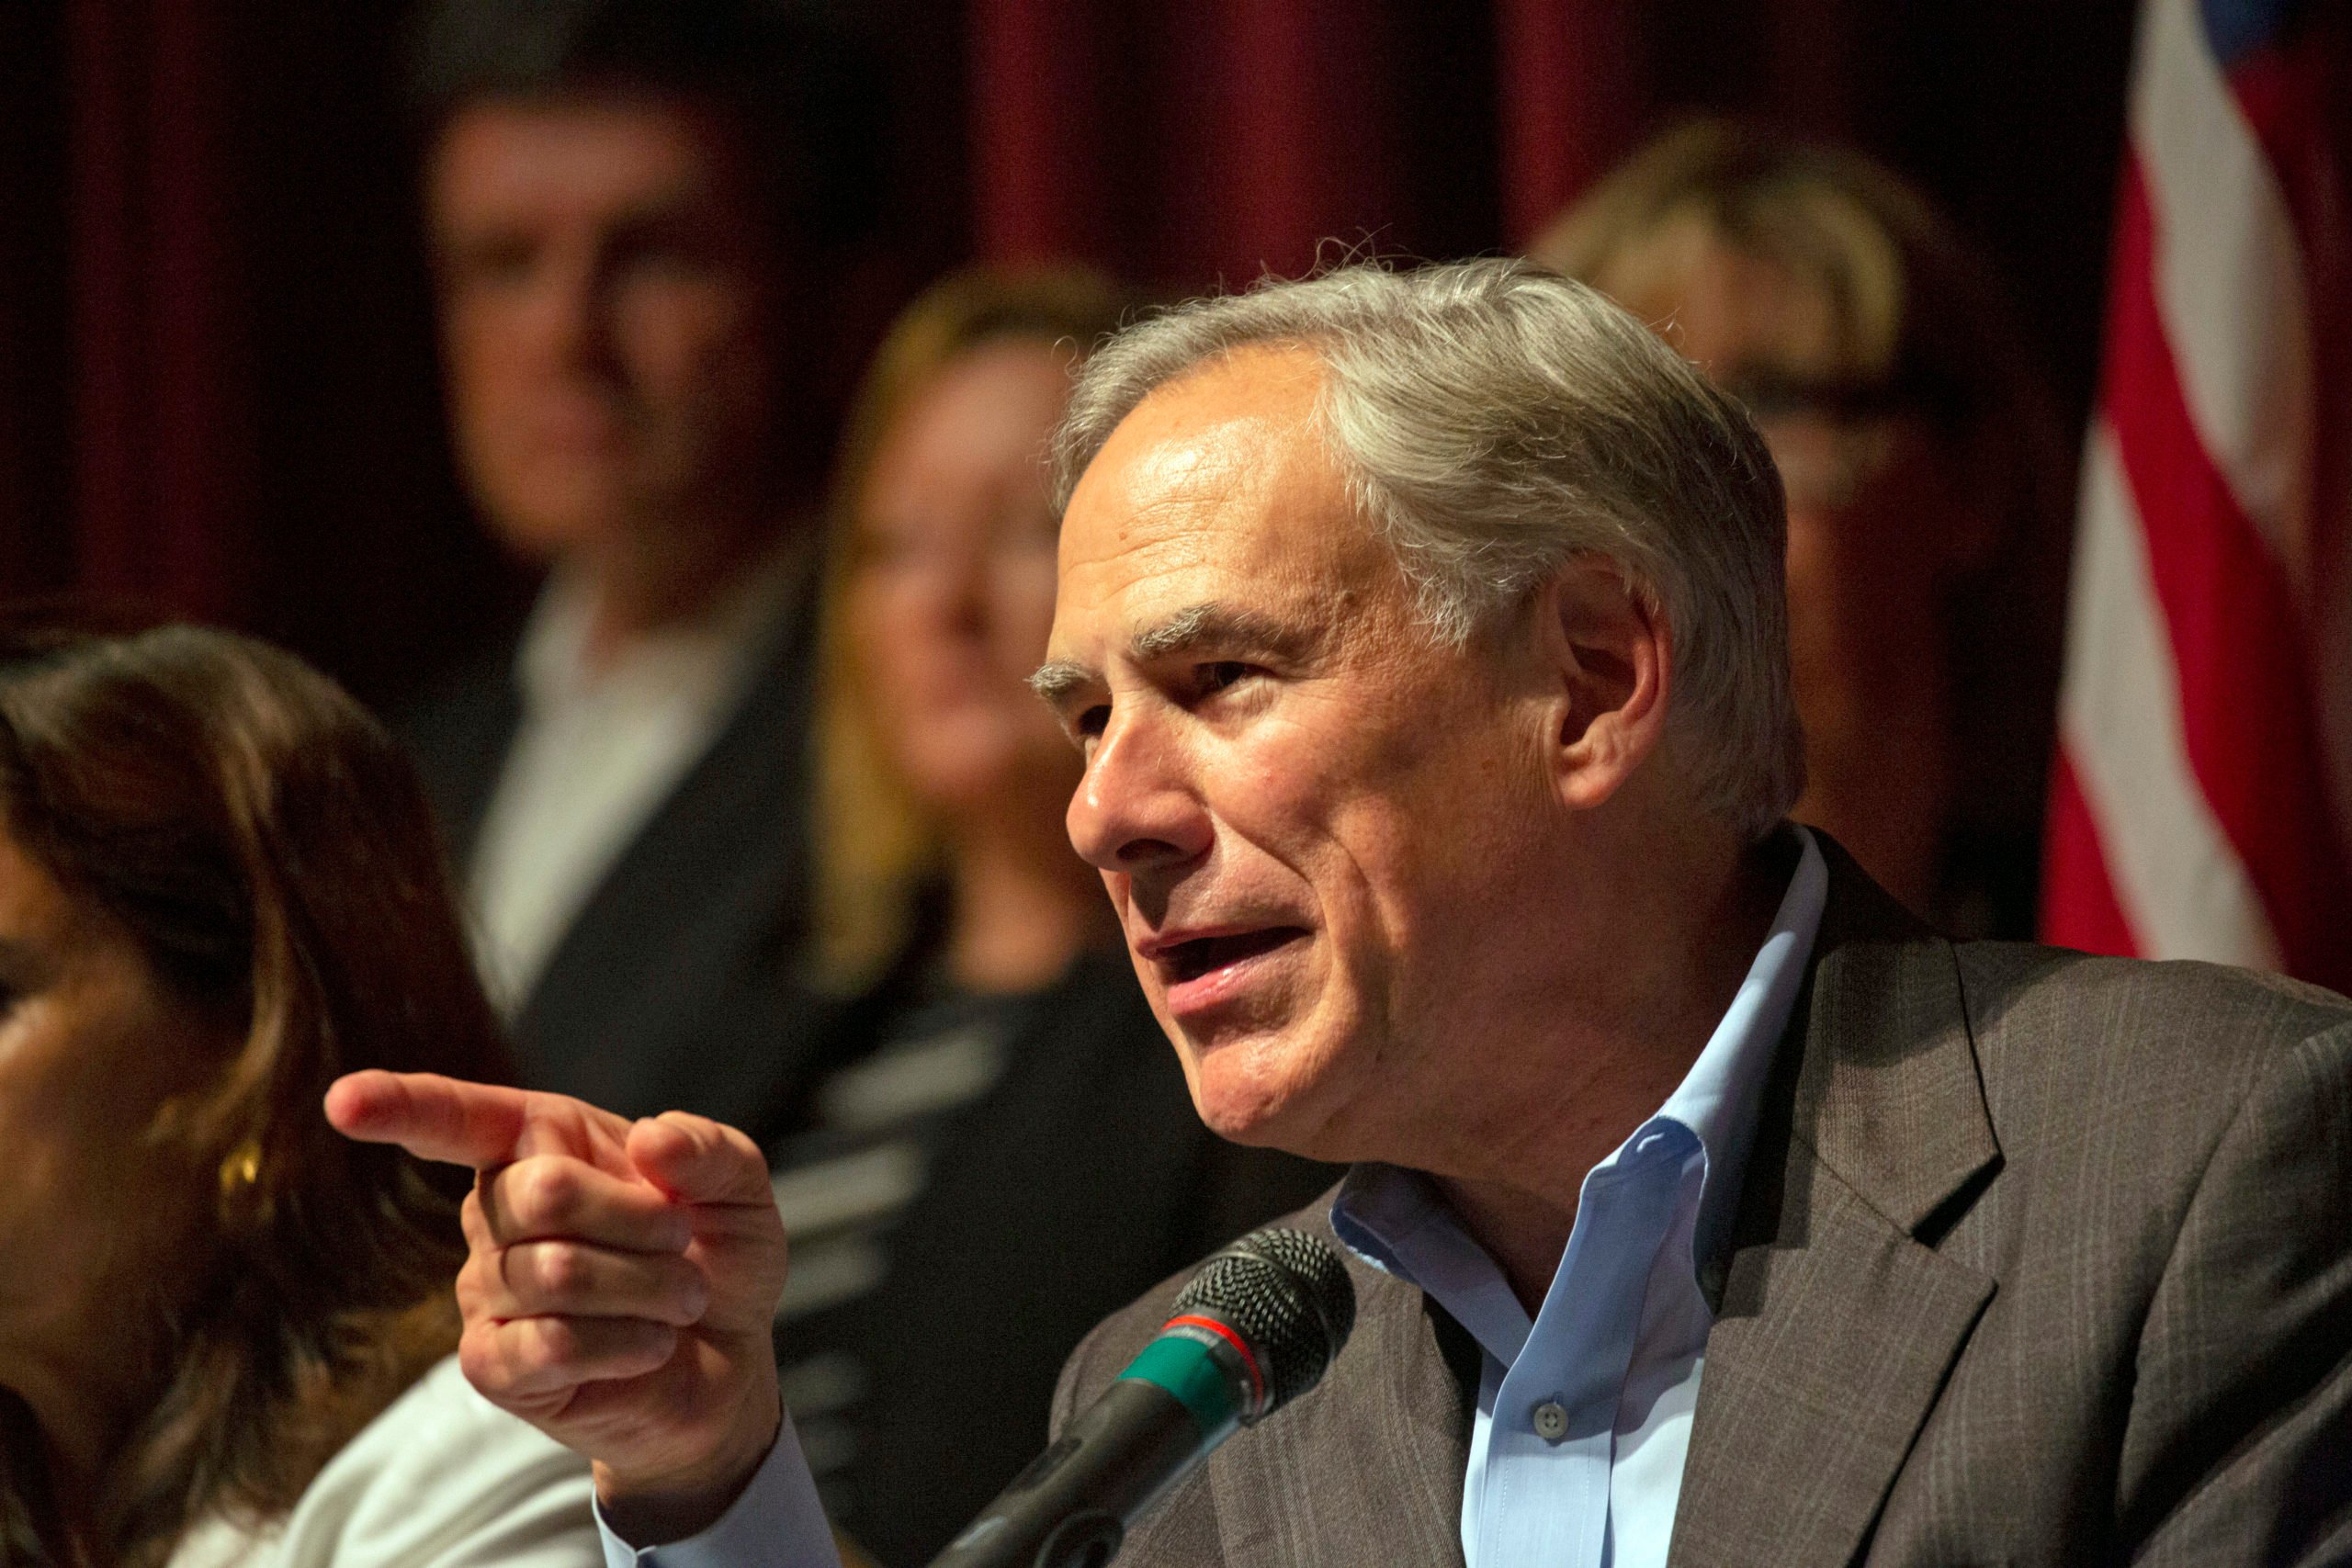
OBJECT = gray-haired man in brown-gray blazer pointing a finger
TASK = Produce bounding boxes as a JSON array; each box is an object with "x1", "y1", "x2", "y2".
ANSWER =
[{"x1": 334, "y1": 261, "x2": 2352, "y2": 1568}]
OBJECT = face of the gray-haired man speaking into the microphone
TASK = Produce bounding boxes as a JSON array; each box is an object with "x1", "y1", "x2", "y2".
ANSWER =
[{"x1": 1037, "y1": 350, "x2": 1547, "y2": 1159}]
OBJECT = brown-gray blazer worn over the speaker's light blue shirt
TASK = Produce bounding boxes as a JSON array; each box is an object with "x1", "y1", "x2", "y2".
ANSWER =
[{"x1": 1056, "y1": 841, "x2": 2352, "y2": 1568}]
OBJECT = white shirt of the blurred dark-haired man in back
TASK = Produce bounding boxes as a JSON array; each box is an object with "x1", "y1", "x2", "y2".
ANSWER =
[{"x1": 466, "y1": 550, "x2": 802, "y2": 1016}]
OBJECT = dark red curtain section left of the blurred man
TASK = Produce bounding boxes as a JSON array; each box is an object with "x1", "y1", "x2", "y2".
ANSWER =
[{"x1": 34, "y1": 0, "x2": 517, "y2": 701}]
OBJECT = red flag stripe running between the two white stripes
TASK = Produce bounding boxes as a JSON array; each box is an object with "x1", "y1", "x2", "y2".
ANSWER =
[{"x1": 2100, "y1": 155, "x2": 2352, "y2": 985}]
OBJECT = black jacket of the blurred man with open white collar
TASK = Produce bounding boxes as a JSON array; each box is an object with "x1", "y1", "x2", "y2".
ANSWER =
[{"x1": 402, "y1": 604, "x2": 837, "y2": 1138}]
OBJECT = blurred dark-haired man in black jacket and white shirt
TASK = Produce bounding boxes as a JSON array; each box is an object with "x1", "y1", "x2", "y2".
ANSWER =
[{"x1": 409, "y1": 0, "x2": 860, "y2": 1131}]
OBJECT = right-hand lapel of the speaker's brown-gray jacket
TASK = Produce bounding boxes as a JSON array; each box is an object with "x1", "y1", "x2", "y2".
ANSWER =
[{"x1": 1670, "y1": 840, "x2": 1999, "y2": 1568}]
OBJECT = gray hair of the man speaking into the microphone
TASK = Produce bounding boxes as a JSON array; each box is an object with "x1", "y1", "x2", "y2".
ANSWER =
[{"x1": 1054, "y1": 261, "x2": 1804, "y2": 837}]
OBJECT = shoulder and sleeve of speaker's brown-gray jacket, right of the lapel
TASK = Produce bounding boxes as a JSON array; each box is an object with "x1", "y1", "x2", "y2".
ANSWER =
[{"x1": 1872, "y1": 942, "x2": 2352, "y2": 1561}]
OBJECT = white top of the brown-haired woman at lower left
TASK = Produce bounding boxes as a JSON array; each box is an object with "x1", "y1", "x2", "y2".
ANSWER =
[{"x1": 167, "y1": 1357, "x2": 605, "y2": 1568}]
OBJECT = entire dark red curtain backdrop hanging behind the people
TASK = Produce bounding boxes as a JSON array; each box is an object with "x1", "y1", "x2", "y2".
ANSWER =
[{"x1": 14, "y1": 0, "x2": 2131, "y2": 703}]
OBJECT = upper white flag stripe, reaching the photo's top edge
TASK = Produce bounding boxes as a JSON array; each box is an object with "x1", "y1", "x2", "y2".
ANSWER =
[{"x1": 2131, "y1": 0, "x2": 2314, "y2": 590}]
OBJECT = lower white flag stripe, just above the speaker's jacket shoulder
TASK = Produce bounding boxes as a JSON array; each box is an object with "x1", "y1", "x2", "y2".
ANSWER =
[{"x1": 2058, "y1": 419, "x2": 2279, "y2": 968}]
